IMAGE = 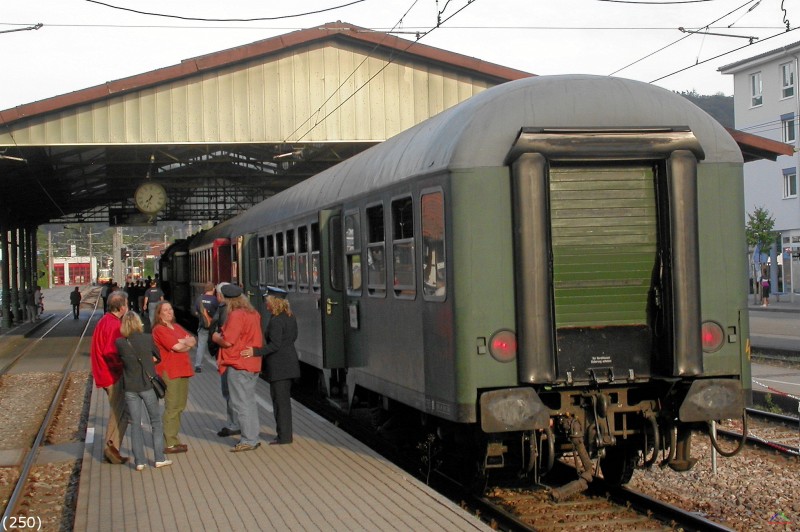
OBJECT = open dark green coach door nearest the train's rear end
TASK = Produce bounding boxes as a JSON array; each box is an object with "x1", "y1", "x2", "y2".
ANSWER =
[{"x1": 319, "y1": 209, "x2": 345, "y2": 368}]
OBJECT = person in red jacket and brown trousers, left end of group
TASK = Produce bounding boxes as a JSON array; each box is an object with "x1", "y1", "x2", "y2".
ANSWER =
[{"x1": 89, "y1": 292, "x2": 130, "y2": 464}]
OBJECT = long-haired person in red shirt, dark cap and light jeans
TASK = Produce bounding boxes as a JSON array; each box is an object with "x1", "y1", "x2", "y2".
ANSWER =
[{"x1": 213, "y1": 284, "x2": 263, "y2": 453}]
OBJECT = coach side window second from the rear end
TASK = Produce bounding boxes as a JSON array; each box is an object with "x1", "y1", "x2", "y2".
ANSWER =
[{"x1": 392, "y1": 197, "x2": 416, "y2": 299}]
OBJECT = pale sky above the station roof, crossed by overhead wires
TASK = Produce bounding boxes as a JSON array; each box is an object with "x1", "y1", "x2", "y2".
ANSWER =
[{"x1": 0, "y1": 0, "x2": 800, "y2": 110}]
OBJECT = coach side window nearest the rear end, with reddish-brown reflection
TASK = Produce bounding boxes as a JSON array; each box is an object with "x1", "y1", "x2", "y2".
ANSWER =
[{"x1": 420, "y1": 191, "x2": 447, "y2": 301}]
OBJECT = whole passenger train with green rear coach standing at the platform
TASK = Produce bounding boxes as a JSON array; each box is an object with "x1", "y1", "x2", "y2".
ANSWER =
[{"x1": 162, "y1": 75, "x2": 750, "y2": 489}]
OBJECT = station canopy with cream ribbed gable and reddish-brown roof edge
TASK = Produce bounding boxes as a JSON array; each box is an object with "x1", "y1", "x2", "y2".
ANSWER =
[{"x1": 0, "y1": 22, "x2": 791, "y2": 227}]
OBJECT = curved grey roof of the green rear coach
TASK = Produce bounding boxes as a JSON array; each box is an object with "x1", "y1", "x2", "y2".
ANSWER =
[{"x1": 229, "y1": 75, "x2": 742, "y2": 236}]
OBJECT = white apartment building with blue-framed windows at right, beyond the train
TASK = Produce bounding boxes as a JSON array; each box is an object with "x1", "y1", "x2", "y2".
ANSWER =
[{"x1": 719, "y1": 42, "x2": 800, "y2": 292}]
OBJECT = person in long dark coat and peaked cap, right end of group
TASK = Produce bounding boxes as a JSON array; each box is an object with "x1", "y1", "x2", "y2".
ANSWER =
[{"x1": 242, "y1": 286, "x2": 300, "y2": 445}]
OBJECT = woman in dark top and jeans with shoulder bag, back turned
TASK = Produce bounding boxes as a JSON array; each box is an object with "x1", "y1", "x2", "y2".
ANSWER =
[{"x1": 116, "y1": 312, "x2": 172, "y2": 471}]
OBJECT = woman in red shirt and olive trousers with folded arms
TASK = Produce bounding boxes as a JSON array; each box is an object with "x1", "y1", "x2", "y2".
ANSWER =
[{"x1": 153, "y1": 301, "x2": 197, "y2": 453}]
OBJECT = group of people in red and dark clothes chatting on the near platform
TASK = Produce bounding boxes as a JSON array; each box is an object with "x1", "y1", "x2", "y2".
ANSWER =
[{"x1": 91, "y1": 283, "x2": 300, "y2": 471}]
